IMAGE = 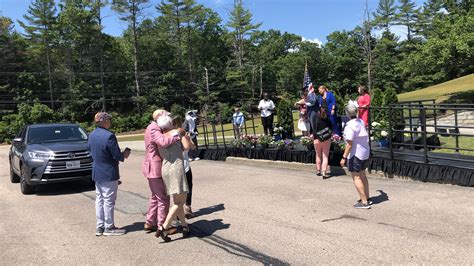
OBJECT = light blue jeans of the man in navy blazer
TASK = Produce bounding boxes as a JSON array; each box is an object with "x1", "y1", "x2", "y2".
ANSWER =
[{"x1": 95, "y1": 180, "x2": 118, "y2": 228}]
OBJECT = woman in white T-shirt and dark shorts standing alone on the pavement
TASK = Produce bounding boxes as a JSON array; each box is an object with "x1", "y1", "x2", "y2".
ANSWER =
[{"x1": 341, "y1": 103, "x2": 370, "y2": 209}]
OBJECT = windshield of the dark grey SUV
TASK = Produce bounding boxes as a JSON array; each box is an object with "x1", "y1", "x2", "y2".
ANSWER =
[{"x1": 28, "y1": 125, "x2": 87, "y2": 144}]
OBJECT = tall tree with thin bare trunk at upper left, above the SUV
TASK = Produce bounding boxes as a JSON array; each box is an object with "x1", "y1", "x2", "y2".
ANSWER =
[{"x1": 19, "y1": 0, "x2": 57, "y2": 108}]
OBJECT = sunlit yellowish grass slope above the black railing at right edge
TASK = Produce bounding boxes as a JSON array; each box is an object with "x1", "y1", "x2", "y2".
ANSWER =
[{"x1": 398, "y1": 74, "x2": 474, "y2": 103}]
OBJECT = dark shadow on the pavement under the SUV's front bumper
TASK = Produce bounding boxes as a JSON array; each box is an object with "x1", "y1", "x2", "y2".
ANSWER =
[{"x1": 35, "y1": 181, "x2": 95, "y2": 196}]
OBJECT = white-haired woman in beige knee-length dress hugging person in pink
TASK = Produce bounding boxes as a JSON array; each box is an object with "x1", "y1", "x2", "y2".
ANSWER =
[{"x1": 155, "y1": 115, "x2": 193, "y2": 242}]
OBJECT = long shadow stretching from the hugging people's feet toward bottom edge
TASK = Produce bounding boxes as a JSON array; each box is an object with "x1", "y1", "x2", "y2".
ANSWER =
[{"x1": 189, "y1": 219, "x2": 289, "y2": 265}]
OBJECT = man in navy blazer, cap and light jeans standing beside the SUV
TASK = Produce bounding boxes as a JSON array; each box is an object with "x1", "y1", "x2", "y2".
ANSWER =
[{"x1": 87, "y1": 112, "x2": 130, "y2": 236}]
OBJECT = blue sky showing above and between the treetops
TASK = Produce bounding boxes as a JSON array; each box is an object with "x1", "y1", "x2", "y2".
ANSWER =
[{"x1": 0, "y1": 0, "x2": 424, "y2": 43}]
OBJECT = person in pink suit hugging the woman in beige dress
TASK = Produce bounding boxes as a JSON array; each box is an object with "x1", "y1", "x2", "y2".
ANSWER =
[{"x1": 142, "y1": 109, "x2": 184, "y2": 233}]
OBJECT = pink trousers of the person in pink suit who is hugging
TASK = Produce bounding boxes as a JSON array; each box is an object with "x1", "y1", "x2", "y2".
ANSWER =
[{"x1": 146, "y1": 177, "x2": 170, "y2": 226}]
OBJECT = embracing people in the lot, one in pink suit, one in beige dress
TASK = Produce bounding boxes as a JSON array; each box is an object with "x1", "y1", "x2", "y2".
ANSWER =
[{"x1": 142, "y1": 110, "x2": 195, "y2": 242}]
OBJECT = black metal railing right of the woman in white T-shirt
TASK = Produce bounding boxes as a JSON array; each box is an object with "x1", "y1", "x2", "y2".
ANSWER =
[{"x1": 369, "y1": 102, "x2": 474, "y2": 169}]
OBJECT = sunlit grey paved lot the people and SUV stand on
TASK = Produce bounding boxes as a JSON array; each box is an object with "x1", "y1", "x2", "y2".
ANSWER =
[{"x1": 0, "y1": 143, "x2": 474, "y2": 265}]
